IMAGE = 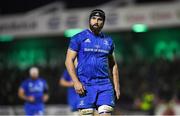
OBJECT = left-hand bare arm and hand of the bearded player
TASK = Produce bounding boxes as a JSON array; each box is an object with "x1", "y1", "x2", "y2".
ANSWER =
[{"x1": 65, "y1": 48, "x2": 84, "y2": 94}]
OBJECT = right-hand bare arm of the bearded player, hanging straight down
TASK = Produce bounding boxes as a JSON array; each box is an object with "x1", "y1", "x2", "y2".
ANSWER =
[{"x1": 108, "y1": 53, "x2": 120, "y2": 99}]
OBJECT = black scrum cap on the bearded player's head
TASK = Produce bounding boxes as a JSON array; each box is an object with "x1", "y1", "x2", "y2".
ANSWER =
[{"x1": 89, "y1": 9, "x2": 106, "y2": 21}]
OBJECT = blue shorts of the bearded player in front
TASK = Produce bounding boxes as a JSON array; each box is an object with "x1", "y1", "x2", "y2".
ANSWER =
[{"x1": 77, "y1": 84, "x2": 115, "y2": 109}]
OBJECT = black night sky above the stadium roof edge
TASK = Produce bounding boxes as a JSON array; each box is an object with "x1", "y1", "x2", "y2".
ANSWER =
[{"x1": 0, "y1": 0, "x2": 175, "y2": 15}]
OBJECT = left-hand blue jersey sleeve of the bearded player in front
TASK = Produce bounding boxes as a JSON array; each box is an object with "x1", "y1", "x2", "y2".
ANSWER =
[{"x1": 69, "y1": 35, "x2": 80, "y2": 52}]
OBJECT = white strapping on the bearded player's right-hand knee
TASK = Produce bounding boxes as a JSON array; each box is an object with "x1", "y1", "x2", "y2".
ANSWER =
[{"x1": 98, "y1": 105, "x2": 113, "y2": 114}]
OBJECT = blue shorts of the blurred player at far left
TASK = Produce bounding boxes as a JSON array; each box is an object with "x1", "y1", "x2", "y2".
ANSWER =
[{"x1": 24, "y1": 104, "x2": 44, "y2": 116}]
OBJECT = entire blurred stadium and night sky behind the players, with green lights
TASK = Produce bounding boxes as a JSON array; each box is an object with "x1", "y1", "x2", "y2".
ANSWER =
[{"x1": 0, "y1": 0, "x2": 180, "y2": 115}]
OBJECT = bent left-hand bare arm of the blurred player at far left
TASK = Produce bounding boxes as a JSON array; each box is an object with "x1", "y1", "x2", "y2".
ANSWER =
[{"x1": 18, "y1": 87, "x2": 35, "y2": 102}]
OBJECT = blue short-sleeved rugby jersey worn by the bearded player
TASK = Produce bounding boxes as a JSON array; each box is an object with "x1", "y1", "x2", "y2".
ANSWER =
[{"x1": 69, "y1": 29, "x2": 114, "y2": 85}]
